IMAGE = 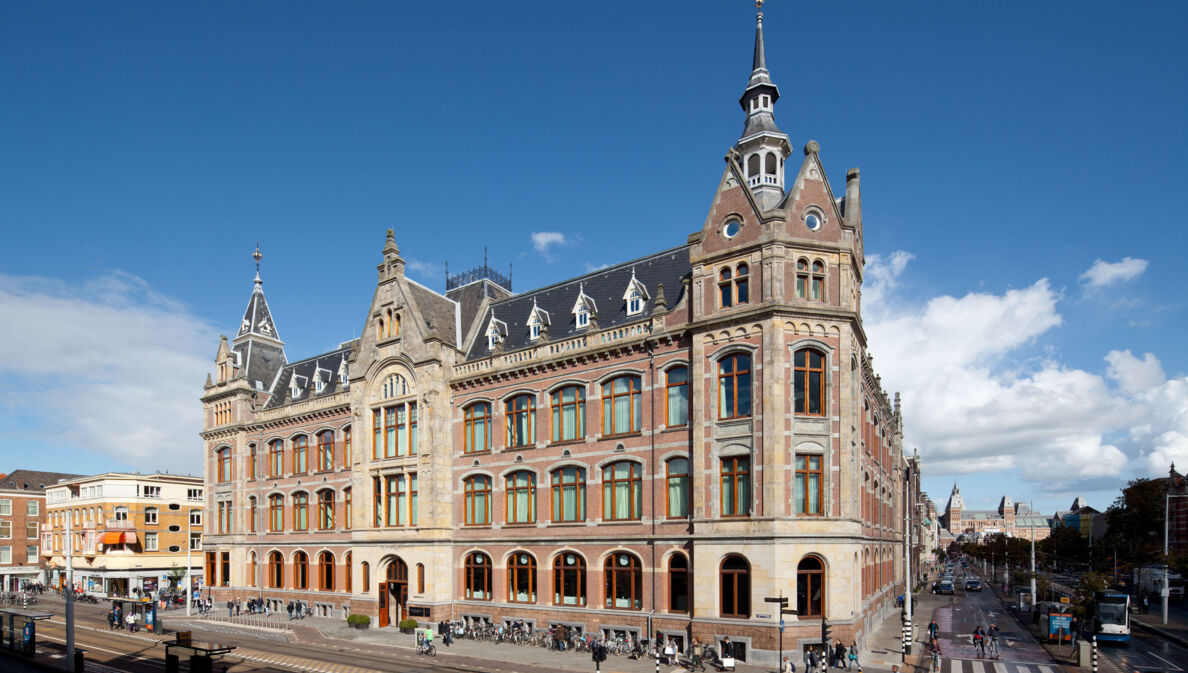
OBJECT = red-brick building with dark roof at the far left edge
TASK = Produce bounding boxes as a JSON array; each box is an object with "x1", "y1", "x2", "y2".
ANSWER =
[{"x1": 0, "y1": 470, "x2": 77, "y2": 591}]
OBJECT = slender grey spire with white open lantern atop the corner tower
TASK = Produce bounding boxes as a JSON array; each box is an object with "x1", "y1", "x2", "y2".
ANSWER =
[{"x1": 734, "y1": 0, "x2": 792, "y2": 209}]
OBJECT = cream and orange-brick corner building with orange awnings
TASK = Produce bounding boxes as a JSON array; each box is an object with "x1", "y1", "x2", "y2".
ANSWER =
[{"x1": 42, "y1": 472, "x2": 206, "y2": 597}]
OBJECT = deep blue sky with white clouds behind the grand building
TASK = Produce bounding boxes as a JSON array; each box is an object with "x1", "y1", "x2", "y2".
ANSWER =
[{"x1": 0, "y1": 0, "x2": 1188, "y2": 520}]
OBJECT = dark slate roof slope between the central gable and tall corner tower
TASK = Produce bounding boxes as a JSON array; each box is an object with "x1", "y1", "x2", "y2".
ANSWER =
[{"x1": 467, "y1": 245, "x2": 693, "y2": 360}]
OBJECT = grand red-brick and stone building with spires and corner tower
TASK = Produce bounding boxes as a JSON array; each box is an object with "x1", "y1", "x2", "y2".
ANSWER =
[{"x1": 203, "y1": 5, "x2": 902, "y2": 663}]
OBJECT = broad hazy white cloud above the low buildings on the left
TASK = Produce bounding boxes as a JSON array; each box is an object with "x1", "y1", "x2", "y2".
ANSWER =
[{"x1": 0, "y1": 272, "x2": 219, "y2": 473}]
